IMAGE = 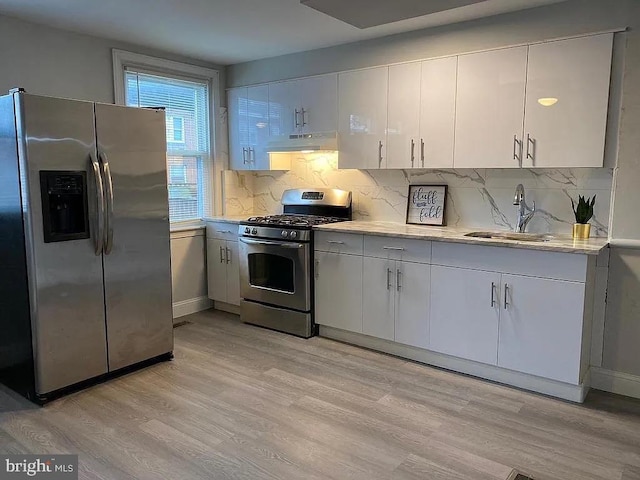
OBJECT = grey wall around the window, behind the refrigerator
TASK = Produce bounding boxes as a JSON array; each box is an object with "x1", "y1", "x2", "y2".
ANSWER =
[{"x1": 0, "y1": 16, "x2": 225, "y2": 312}]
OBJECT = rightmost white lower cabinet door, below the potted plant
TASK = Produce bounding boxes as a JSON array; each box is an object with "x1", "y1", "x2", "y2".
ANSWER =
[{"x1": 498, "y1": 275, "x2": 585, "y2": 385}]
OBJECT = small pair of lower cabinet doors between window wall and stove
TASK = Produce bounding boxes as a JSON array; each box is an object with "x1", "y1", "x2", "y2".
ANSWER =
[{"x1": 207, "y1": 238, "x2": 240, "y2": 305}]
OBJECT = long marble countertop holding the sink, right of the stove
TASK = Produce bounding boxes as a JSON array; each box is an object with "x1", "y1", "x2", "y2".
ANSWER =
[{"x1": 314, "y1": 221, "x2": 609, "y2": 255}]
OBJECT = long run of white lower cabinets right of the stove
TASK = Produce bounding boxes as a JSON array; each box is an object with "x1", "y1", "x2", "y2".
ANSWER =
[{"x1": 315, "y1": 232, "x2": 596, "y2": 401}]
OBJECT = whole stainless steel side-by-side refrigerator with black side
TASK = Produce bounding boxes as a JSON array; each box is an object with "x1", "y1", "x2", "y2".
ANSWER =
[{"x1": 0, "y1": 91, "x2": 173, "y2": 401}]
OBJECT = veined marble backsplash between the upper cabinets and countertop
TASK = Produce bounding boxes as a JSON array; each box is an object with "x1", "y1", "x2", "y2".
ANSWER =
[{"x1": 223, "y1": 153, "x2": 613, "y2": 236}]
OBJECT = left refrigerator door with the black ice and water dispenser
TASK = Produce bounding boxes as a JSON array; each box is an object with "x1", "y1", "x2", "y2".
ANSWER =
[{"x1": 14, "y1": 94, "x2": 107, "y2": 396}]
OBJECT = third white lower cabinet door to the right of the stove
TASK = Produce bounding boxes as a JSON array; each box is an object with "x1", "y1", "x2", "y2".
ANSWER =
[{"x1": 395, "y1": 262, "x2": 431, "y2": 348}]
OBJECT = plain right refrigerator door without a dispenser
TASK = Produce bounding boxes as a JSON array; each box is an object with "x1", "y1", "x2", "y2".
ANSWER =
[{"x1": 95, "y1": 104, "x2": 173, "y2": 371}]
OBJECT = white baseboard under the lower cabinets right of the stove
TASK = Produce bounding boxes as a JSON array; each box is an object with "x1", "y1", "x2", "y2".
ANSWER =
[{"x1": 320, "y1": 325, "x2": 590, "y2": 403}]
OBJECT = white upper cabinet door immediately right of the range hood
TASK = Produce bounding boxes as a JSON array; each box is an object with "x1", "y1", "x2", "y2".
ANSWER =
[{"x1": 338, "y1": 67, "x2": 389, "y2": 169}]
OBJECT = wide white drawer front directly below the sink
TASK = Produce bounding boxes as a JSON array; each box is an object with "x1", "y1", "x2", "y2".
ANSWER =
[{"x1": 431, "y1": 242, "x2": 588, "y2": 283}]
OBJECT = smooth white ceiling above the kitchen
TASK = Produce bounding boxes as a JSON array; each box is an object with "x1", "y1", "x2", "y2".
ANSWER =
[{"x1": 0, "y1": 0, "x2": 563, "y2": 65}]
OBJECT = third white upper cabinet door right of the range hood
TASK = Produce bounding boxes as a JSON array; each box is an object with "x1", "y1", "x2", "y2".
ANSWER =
[{"x1": 416, "y1": 57, "x2": 458, "y2": 168}]
